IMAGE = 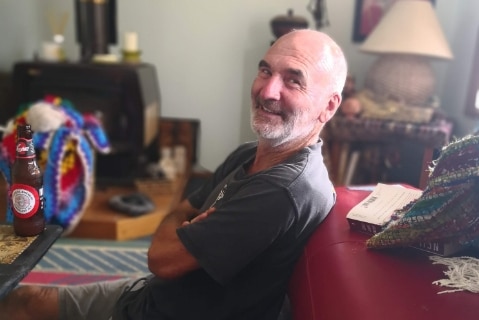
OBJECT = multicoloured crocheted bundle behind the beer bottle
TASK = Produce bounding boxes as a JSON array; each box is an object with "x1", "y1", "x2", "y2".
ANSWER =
[{"x1": 0, "y1": 96, "x2": 110, "y2": 234}]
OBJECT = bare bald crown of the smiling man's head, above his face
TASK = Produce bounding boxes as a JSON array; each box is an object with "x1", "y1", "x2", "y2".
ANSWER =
[{"x1": 270, "y1": 29, "x2": 347, "y2": 93}]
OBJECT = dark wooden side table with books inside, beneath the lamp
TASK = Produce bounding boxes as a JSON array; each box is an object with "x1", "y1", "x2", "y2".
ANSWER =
[{"x1": 322, "y1": 116, "x2": 452, "y2": 188}]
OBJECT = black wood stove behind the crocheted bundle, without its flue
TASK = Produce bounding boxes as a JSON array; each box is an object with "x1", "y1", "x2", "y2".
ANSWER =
[{"x1": 6, "y1": 62, "x2": 160, "y2": 182}]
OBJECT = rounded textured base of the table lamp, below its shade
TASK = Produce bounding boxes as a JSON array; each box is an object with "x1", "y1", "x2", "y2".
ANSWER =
[{"x1": 365, "y1": 54, "x2": 435, "y2": 106}]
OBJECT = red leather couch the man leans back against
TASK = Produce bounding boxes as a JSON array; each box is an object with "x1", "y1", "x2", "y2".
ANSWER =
[{"x1": 289, "y1": 187, "x2": 479, "y2": 320}]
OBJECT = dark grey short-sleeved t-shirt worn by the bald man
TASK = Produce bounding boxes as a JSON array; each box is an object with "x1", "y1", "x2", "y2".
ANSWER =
[{"x1": 115, "y1": 143, "x2": 335, "y2": 320}]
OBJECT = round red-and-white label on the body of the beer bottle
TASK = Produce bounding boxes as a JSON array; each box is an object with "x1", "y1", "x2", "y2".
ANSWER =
[{"x1": 11, "y1": 184, "x2": 43, "y2": 219}]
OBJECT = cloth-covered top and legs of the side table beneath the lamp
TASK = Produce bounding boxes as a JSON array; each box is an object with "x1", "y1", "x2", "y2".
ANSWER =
[{"x1": 322, "y1": 115, "x2": 452, "y2": 189}]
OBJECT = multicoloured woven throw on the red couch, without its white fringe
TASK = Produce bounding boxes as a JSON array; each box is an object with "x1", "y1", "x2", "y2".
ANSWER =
[{"x1": 367, "y1": 135, "x2": 479, "y2": 248}]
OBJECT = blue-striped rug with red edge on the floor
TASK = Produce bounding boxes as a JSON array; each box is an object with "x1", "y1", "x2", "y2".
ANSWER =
[{"x1": 20, "y1": 239, "x2": 149, "y2": 286}]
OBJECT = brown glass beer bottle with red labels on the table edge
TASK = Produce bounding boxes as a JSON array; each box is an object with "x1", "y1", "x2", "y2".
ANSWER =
[{"x1": 10, "y1": 124, "x2": 45, "y2": 237}]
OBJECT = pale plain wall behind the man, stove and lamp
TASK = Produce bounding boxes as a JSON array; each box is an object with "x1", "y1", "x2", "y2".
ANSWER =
[{"x1": 0, "y1": 0, "x2": 479, "y2": 169}]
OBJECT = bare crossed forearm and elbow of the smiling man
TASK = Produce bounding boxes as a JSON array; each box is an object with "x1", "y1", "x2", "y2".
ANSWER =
[{"x1": 148, "y1": 199, "x2": 214, "y2": 279}]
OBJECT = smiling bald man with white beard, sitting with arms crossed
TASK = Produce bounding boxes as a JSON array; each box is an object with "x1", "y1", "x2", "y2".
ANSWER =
[{"x1": 0, "y1": 30, "x2": 347, "y2": 320}]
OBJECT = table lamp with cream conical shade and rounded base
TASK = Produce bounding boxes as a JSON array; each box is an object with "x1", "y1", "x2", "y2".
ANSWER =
[{"x1": 360, "y1": 0, "x2": 453, "y2": 106}]
